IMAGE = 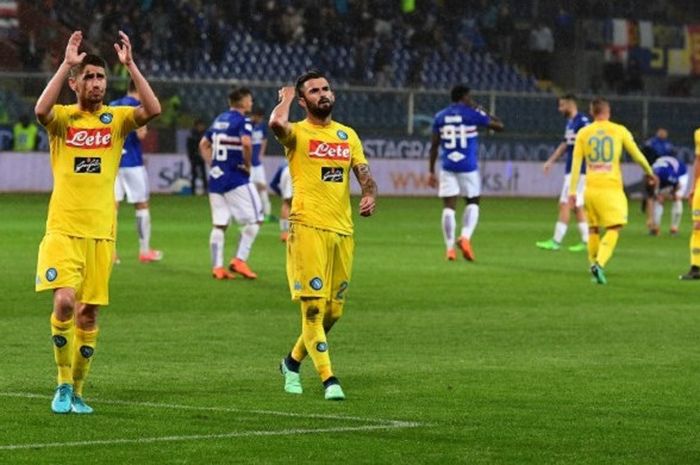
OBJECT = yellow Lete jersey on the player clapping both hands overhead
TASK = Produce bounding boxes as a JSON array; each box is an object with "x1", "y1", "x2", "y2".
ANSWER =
[{"x1": 46, "y1": 104, "x2": 137, "y2": 239}]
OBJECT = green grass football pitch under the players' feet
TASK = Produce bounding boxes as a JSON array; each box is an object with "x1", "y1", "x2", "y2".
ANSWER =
[{"x1": 0, "y1": 195, "x2": 700, "y2": 465}]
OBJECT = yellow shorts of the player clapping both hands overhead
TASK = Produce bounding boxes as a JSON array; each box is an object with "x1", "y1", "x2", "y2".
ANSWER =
[{"x1": 35, "y1": 233, "x2": 115, "y2": 305}]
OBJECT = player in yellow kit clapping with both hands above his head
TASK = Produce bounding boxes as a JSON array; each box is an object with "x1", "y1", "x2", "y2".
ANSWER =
[{"x1": 34, "y1": 31, "x2": 160, "y2": 414}]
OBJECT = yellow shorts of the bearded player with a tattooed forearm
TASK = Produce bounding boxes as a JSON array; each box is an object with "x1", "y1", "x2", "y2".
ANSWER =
[{"x1": 287, "y1": 223, "x2": 355, "y2": 301}]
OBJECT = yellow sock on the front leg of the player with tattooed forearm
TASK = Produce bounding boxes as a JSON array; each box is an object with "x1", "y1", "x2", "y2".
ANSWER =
[{"x1": 301, "y1": 299, "x2": 333, "y2": 381}]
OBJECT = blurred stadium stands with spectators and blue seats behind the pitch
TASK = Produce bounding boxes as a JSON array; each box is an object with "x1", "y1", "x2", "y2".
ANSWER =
[{"x1": 0, "y1": 0, "x2": 700, "y2": 152}]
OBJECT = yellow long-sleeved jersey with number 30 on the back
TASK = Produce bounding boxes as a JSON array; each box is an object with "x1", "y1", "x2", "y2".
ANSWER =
[{"x1": 569, "y1": 121, "x2": 653, "y2": 195}]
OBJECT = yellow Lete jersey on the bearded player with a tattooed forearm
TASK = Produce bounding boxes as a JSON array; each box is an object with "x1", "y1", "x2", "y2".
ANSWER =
[{"x1": 280, "y1": 120, "x2": 367, "y2": 234}]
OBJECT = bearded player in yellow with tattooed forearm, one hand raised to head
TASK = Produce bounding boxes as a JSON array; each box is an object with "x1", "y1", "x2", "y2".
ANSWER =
[{"x1": 270, "y1": 71, "x2": 377, "y2": 400}]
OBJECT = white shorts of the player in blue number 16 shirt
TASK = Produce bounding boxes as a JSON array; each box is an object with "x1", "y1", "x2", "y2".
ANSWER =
[{"x1": 209, "y1": 183, "x2": 265, "y2": 226}]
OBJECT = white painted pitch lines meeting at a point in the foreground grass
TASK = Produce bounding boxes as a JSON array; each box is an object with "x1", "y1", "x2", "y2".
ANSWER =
[{"x1": 0, "y1": 392, "x2": 421, "y2": 450}]
